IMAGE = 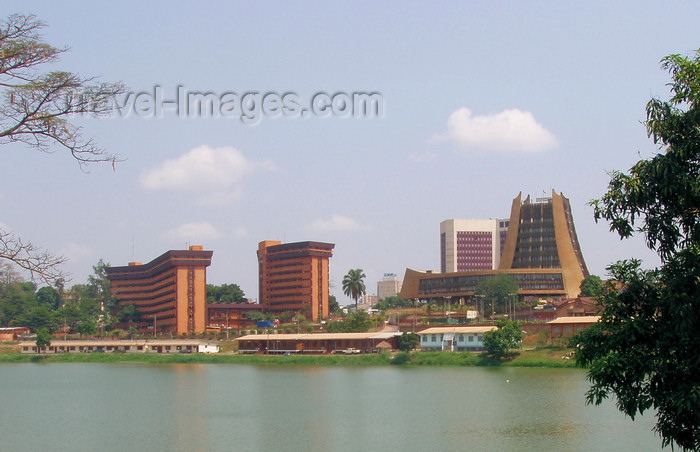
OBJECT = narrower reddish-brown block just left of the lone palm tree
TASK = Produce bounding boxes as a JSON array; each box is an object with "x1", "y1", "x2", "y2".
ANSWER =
[{"x1": 258, "y1": 240, "x2": 335, "y2": 322}]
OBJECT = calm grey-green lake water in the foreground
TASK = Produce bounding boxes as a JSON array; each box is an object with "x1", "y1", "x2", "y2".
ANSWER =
[{"x1": 0, "y1": 364, "x2": 660, "y2": 452}]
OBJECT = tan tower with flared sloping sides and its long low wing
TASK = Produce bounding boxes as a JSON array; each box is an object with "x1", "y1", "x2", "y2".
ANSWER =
[{"x1": 400, "y1": 190, "x2": 588, "y2": 300}]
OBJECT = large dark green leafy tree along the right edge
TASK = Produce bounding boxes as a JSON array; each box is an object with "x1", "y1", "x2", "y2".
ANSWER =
[{"x1": 574, "y1": 51, "x2": 700, "y2": 450}]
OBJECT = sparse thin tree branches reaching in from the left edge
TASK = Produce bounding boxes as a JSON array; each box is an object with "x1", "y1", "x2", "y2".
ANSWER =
[{"x1": 0, "y1": 14, "x2": 125, "y2": 285}]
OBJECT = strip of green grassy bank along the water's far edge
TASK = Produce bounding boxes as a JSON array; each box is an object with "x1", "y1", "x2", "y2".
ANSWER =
[{"x1": 0, "y1": 348, "x2": 575, "y2": 367}]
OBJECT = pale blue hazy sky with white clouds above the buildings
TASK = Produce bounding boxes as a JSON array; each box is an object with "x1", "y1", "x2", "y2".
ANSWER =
[{"x1": 0, "y1": 1, "x2": 700, "y2": 304}]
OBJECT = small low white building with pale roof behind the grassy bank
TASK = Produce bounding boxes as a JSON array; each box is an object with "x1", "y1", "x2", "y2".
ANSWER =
[{"x1": 418, "y1": 325, "x2": 497, "y2": 351}]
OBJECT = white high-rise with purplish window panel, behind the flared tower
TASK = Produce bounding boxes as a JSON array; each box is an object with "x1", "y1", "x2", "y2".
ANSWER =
[{"x1": 440, "y1": 219, "x2": 509, "y2": 273}]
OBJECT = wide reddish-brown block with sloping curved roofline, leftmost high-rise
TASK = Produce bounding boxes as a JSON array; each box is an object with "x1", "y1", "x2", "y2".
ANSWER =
[{"x1": 105, "y1": 245, "x2": 213, "y2": 334}]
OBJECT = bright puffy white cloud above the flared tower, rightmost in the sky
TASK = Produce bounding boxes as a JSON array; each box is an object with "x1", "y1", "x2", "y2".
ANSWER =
[{"x1": 438, "y1": 107, "x2": 559, "y2": 152}]
